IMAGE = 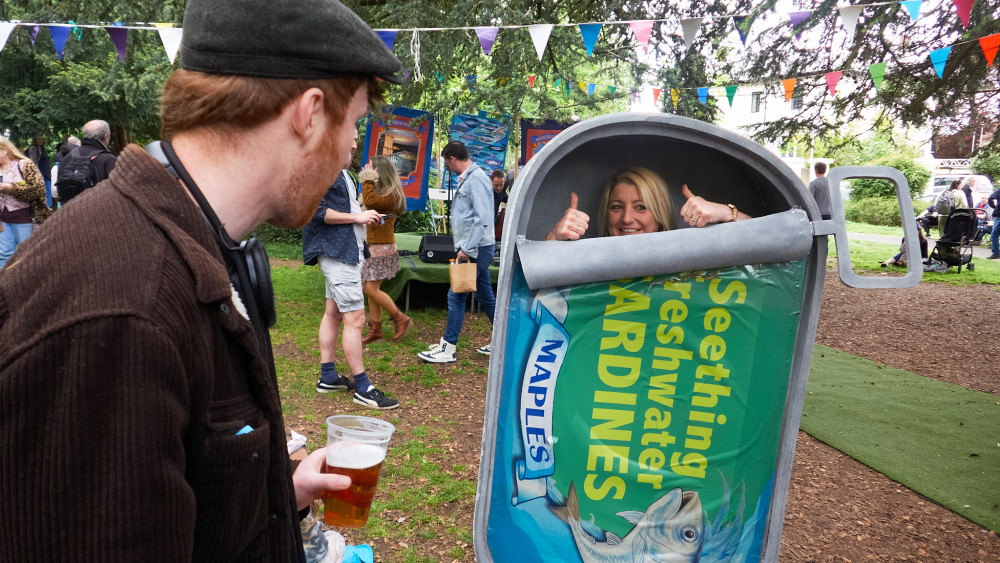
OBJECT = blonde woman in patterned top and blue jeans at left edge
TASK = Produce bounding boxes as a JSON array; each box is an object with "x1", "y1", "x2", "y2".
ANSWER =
[{"x1": 0, "y1": 137, "x2": 52, "y2": 269}]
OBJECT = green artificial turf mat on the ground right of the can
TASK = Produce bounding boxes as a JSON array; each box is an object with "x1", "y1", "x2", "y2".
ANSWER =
[{"x1": 799, "y1": 345, "x2": 1000, "y2": 532}]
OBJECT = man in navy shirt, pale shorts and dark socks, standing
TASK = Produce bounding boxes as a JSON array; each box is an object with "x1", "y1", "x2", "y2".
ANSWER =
[{"x1": 302, "y1": 154, "x2": 399, "y2": 410}]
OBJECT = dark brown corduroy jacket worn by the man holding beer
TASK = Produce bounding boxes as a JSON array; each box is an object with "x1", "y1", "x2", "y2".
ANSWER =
[{"x1": 0, "y1": 145, "x2": 303, "y2": 562}]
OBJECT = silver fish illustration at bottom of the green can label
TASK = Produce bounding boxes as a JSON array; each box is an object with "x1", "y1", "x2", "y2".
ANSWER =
[{"x1": 549, "y1": 483, "x2": 704, "y2": 563}]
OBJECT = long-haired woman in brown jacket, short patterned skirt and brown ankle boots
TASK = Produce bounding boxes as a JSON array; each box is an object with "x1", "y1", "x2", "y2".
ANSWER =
[{"x1": 359, "y1": 156, "x2": 413, "y2": 344}]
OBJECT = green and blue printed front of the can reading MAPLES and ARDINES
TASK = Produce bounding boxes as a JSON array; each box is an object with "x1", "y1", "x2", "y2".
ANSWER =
[{"x1": 486, "y1": 259, "x2": 807, "y2": 562}]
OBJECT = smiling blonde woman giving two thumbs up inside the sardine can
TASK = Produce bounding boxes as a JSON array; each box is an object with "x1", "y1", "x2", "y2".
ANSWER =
[{"x1": 545, "y1": 166, "x2": 751, "y2": 240}]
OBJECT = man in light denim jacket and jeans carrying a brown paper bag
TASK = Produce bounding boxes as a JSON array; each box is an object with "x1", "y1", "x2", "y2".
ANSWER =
[{"x1": 418, "y1": 141, "x2": 496, "y2": 364}]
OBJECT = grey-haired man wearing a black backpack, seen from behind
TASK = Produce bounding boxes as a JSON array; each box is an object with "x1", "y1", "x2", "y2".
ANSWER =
[{"x1": 56, "y1": 119, "x2": 116, "y2": 205}]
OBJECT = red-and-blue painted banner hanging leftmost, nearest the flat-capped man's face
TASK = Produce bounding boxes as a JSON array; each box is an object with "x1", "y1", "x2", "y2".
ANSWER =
[{"x1": 361, "y1": 106, "x2": 434, "y2": 211}]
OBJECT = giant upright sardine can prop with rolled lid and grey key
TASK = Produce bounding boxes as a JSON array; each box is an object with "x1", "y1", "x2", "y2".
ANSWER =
[{"x1": 474, "y1": 113, "x2": 922, "y2": 563}]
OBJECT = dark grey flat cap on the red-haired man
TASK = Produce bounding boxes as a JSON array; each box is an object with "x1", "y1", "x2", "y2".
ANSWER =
[{"x1": 181, "y1": 0, "x2": 402, "y2": 84}]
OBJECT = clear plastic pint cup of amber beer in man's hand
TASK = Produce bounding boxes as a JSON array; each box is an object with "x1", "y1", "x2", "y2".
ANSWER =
[{"x1": 323, "y1": 415, "x2": 396, "y2": 528}]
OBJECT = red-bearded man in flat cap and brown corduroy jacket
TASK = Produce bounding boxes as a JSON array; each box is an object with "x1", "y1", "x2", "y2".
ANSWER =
[{"x1": 0, "y1": 0, "x2": 400, "y2": 563}]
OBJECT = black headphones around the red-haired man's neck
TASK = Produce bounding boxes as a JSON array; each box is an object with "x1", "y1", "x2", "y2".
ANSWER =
[{"x1": 146, "y1": 141, "x2": 277, "y2": 338}]
